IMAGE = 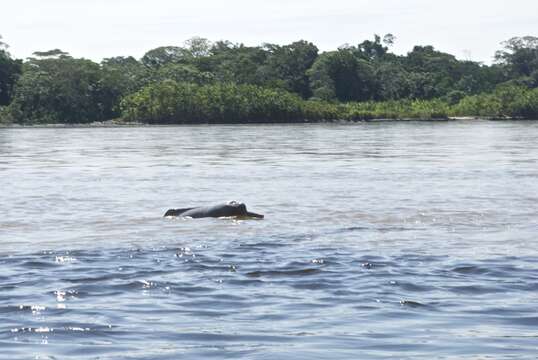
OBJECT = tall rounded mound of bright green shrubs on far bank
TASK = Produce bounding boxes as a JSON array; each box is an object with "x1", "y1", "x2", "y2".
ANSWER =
[{"x1": 122, "y1": 80, "x2": 303, "y2": 124}]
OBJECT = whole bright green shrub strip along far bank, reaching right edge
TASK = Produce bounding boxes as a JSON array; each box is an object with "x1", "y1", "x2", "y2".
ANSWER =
[{"x1": 117, "y1": 81, "x2": 538, "y2": 124}]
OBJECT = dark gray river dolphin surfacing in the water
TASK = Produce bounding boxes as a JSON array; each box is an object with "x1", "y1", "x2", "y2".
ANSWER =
[{"x1": 164, "y1": 201, "x2": 263, "y2": 219}]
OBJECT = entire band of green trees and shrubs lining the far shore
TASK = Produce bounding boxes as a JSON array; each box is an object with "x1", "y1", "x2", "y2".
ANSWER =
[{"x1": 0, "y1": 34, "x2": 538, "y2": 124}]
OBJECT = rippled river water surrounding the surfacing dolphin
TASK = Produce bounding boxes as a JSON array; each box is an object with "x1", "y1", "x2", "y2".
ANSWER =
[{"x1": 0, "y1": 121, "x2": 538, "y2": 359}]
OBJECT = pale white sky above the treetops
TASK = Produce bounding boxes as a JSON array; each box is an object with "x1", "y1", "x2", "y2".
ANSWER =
[{"x1": 0, "y1": 0, "x2": 538, "y2": 63}]
